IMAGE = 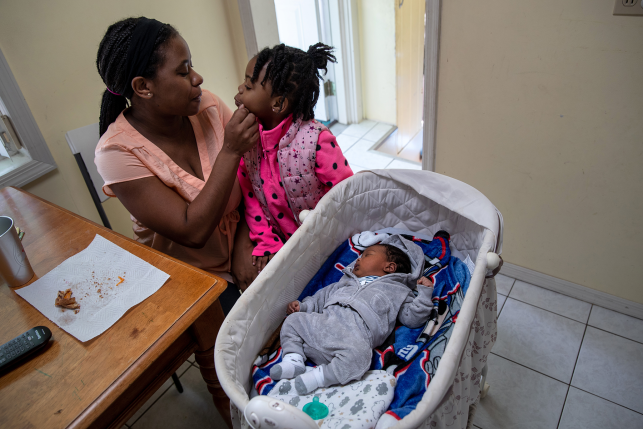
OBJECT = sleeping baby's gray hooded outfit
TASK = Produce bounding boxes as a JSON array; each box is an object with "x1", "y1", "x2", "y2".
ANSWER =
[{"x1": 281, "y1": 235, "x2": 433, "y2": 386}]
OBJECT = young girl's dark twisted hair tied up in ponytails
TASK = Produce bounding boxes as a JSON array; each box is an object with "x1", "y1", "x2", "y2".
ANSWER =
[{"x1": 250, "y1": 43, "x2": 337, "y2": 121}]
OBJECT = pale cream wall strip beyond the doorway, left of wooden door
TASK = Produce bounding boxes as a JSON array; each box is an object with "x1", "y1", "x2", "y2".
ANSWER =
[{"x1": 357, "y1": 0, "x2": 396, "y2": 124}]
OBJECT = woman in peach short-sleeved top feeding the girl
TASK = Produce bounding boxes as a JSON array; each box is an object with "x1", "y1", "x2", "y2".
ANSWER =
[{"x1": 95, "y1": 18, "x2": 259, "y2": 313}]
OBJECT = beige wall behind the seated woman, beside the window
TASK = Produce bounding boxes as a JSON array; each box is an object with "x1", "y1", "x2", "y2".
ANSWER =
[{"x1": 0, "y1": 0, "x2": 247, "y2": 236}]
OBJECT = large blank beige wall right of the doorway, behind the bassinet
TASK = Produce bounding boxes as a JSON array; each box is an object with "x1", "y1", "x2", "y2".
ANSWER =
[{"x1": 436, "y1": 0, "x2": 643, "y2": 303}]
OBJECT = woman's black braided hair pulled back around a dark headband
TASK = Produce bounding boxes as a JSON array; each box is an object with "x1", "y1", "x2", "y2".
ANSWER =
[{"x1": 96, "y1": 18, "x2": 179, "y2": 136}]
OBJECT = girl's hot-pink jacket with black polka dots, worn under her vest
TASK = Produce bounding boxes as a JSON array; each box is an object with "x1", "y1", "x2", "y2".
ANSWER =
[{"x1": 237, "y1": 115, "x2": 353, "y2": 256}]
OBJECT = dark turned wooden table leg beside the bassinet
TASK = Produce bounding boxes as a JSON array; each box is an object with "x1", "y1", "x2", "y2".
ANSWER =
[{"x1": 190, "y1": 300, "x2": 232, "y2": 428}]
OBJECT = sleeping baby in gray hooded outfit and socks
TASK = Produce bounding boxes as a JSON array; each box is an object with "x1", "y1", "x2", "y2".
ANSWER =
[{"x1": 270, "y1": 235, "x2": 433, "y2": 395}]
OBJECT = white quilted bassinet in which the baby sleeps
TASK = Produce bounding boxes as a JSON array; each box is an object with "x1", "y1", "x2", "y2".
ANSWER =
[{"x1": 215, "y1": 170, "x2": 502, "y2": 428}]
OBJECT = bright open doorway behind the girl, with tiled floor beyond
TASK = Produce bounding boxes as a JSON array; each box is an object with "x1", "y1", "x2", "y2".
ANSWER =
[{"x1": 238, "y1": 0, "x2": 439, "y2": 170}]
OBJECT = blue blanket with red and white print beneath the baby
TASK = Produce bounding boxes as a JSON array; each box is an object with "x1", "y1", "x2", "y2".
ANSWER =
[{"x1": 252, "y1": 231, "x2": 471, "y2": 420}]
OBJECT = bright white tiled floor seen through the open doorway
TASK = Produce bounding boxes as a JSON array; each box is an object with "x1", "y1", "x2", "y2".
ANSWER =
[{"x1": 331, "y1": 120, "x2": 422, "y2": 173}]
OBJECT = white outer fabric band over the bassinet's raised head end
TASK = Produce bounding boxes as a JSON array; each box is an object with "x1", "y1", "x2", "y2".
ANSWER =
[{"x1": 352, "y1": 170, "x2": 503, "y2": 254}]
